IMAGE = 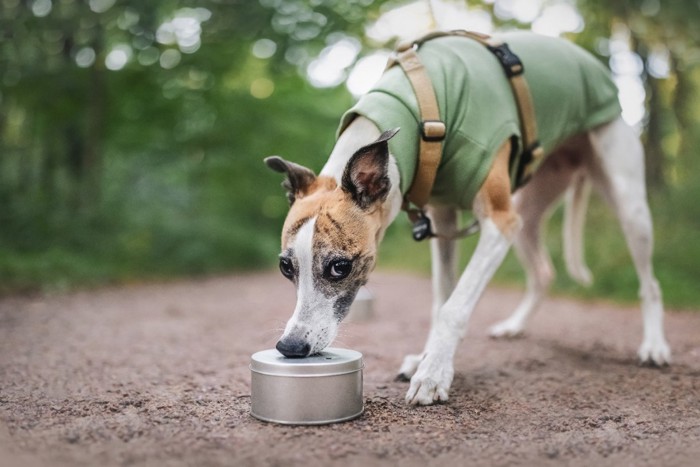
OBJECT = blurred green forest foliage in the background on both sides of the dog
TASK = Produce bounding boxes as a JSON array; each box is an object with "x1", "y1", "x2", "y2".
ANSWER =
[{"x1": 0, "y1": 0, "x2": 700, "y2": 307}]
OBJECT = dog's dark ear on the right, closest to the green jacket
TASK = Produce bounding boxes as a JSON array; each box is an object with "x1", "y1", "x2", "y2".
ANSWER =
[{"x1": 342, "y1": 128, "x2": 399, "y2": 209}]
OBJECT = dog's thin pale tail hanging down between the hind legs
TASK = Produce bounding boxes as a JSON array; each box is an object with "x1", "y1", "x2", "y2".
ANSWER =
[{"x1": 563, "y1": 172, "x2": 593, "y2": 286}]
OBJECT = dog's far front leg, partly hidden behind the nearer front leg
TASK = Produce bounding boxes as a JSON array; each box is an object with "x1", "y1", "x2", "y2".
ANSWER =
[{"x1": 398, "y1": 206, "x2": 459, "y2": 380}]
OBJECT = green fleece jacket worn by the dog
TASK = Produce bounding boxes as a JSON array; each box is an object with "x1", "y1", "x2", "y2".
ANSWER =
[{"x1": 339, "y1": 32, "x2": 620, "y2": 209}]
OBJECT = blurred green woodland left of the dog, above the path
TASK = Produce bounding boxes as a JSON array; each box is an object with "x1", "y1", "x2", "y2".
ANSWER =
[{"x1": 0, "y1": 0, "x2": 394, "y2": 292}]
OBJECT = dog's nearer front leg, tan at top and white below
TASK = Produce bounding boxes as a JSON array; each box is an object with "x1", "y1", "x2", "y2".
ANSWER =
[{"x1": 406, "y1": 143, "x2": 520, "y2": 405}]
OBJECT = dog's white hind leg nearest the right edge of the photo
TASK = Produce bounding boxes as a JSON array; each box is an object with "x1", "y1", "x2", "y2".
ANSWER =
[{"x1": 591, "y1": 119, "x2": 671, "y2": 365}]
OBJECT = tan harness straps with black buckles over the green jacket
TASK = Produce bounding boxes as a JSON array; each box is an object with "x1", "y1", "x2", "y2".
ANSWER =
[{"x1": 387, "y1": 30, "x2": 544, "y2": 239}]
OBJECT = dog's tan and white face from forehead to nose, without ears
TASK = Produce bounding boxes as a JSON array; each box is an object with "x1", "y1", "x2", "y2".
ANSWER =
[{"x1": 277, "y1": 180, "x2": 380, "y2": 356}]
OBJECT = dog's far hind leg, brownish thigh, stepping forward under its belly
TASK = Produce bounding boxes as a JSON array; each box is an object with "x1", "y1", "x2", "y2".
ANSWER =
[{"x1": 489, "y1": 135, "x2": 590, "y2": 337}]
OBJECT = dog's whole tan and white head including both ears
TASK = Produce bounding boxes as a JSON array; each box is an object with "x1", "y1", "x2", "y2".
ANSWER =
[{"x1": 265, "y1": 130, "x2": 398, "y2": 357}]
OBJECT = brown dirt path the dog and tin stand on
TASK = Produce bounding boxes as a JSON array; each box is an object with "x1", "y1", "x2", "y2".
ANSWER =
[{"x1": 0, "y1": 274, "x2": 700, "y2": 467}]
